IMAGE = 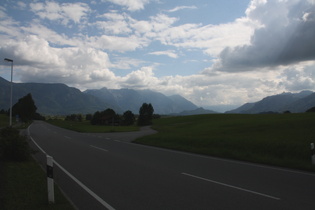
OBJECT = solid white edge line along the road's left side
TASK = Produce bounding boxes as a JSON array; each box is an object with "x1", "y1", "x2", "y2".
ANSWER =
[{"x1": 27, "y1": 126, "x2": 115, "y2": 210}]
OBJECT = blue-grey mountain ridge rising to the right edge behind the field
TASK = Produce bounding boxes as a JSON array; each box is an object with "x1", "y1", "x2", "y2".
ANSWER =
[{"x1": 226, "y1": 91, "x2": 315, "y2": 114}]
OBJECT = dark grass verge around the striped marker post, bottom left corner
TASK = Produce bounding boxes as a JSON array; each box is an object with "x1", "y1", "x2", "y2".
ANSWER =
[{"x1": 0, "y1": 159, "x2": 74, "y2": 210}]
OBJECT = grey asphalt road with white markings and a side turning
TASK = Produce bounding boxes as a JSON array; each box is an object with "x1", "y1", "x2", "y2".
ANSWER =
[{"x1": 28, "y1": 121, "x2": 315, "y2": 210}]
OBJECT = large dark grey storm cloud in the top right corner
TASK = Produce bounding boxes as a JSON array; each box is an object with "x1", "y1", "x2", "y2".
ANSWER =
[{"x1": 214, "y1": 0, "x2": 315, "y2": 72}]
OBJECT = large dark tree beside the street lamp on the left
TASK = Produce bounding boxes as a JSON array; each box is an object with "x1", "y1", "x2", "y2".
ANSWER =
[{"x1": 12, "y1": 93, "x2": 37, "y2": 122}]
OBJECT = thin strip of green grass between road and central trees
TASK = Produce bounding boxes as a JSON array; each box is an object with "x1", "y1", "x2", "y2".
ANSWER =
[{"x1": 47, "y1": 119, "x2": 139, "y2": 133}]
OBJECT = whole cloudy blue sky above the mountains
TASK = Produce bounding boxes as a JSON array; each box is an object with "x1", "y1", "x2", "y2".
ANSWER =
[{"x1": 0, "y1": 0, "x2": 315, "y2": 111}]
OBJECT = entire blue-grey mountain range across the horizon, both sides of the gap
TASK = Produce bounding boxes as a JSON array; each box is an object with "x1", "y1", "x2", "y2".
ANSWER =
[{"x1": 0, "y1": 77, "x2": 315, "y2": 115}]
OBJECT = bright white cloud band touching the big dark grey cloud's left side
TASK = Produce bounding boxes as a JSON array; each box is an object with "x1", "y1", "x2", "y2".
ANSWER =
[{"x1": 156, "y1": 18, "x2": 259, "y2": 57}]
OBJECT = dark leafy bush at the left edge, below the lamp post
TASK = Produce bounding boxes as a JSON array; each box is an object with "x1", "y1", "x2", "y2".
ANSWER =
[{"x1": 0, "y1": 127, "x2": 30, "y2": 161}]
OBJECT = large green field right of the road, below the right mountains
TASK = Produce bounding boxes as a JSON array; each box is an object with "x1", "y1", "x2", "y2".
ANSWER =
[{"x1": 135, "y1": 113, "x2": 315, "y2": 171}]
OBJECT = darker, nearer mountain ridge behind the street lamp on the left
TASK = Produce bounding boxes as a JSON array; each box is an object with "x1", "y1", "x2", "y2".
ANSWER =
[{"x1": 0, "y1": 77, "x2": 108, "y2": 115}]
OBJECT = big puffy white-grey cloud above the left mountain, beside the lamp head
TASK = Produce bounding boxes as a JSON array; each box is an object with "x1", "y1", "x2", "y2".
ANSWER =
[{"x1": 0, "y1": 35, "x2": 115, "y2": 85}]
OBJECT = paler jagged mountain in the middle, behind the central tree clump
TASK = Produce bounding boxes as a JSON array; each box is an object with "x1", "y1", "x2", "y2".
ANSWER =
[{"x1": 84, "y1": 88, "x2": 197, "y2": 114}]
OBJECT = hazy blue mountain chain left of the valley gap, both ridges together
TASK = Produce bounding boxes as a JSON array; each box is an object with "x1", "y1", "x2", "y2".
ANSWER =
[{"x1": 0, "y1": 77, "x2": 198, "y2": 115}]
